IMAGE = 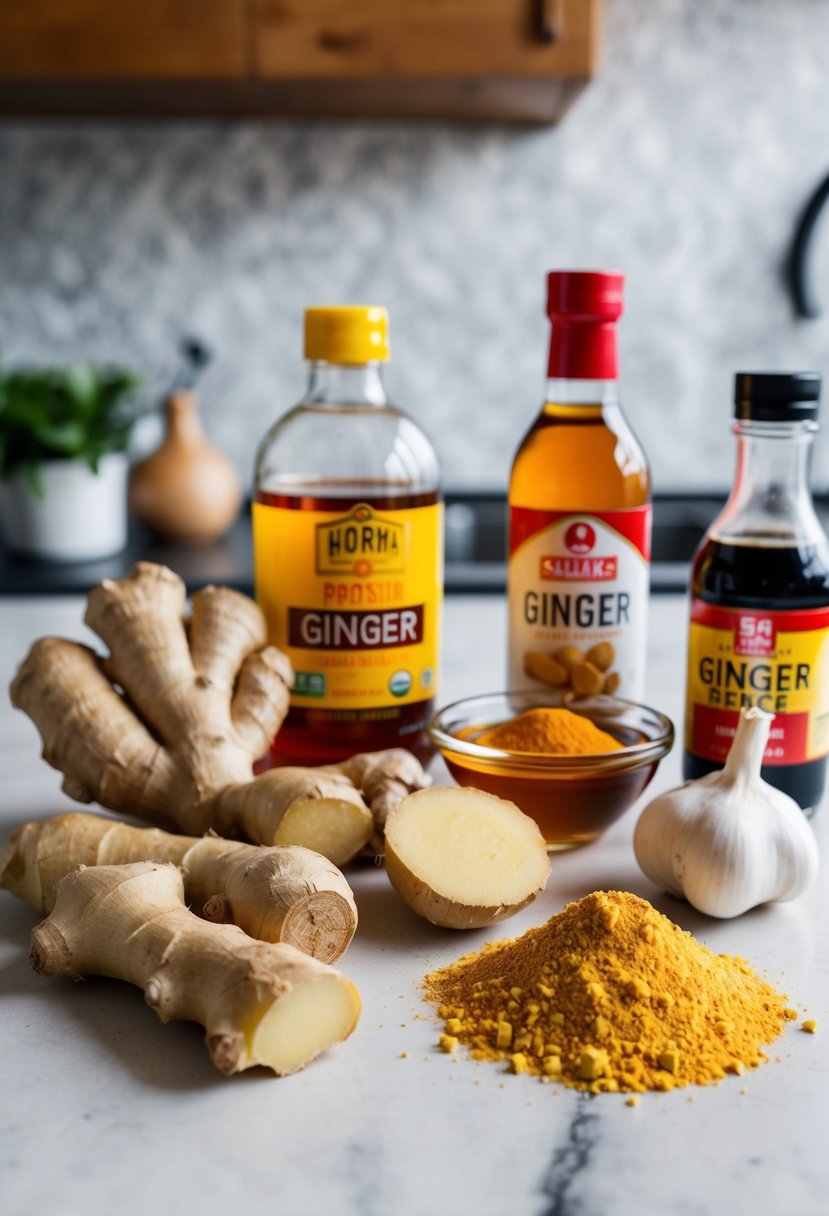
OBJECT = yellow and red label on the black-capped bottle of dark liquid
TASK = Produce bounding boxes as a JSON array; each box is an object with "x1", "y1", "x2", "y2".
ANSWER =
[{"x1": 686, "y1": 599, "x2": 829, "y2": 765}]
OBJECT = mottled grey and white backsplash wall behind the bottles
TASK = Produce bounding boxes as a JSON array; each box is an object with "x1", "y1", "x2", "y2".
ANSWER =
[{"x1": 0, "y1": 0, "x2": 829, "y2": 490}]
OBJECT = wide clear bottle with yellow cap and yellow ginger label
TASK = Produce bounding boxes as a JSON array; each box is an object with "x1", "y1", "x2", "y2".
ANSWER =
[{"x1": 253, "y1": 306, "x2": 442, "y2": 764}]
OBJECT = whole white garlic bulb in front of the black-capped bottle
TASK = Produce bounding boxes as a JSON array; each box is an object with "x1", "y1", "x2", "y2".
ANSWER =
[{"x1": 633, "y1": 708, "x2": 818, "y2": 917}]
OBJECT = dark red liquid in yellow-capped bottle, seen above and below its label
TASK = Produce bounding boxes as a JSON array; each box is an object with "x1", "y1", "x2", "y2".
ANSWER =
[{"x1": 256, "y1": 480, "x2": 440, "y2": 771}]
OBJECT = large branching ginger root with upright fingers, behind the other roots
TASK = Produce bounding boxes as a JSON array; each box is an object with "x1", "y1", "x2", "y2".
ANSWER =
[{"x1": 11, "y1": 562, "x2": 293, "y2": 844}]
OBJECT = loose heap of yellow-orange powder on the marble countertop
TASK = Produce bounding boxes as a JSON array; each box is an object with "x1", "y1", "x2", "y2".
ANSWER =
[{"x1": 424, "y1": 891, "x2": 795, "y2": 1093}]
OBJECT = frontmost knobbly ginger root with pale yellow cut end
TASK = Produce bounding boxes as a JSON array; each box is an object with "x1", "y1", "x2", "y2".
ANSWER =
[{"x1": 30, "y1": 862, "x2": 360, "y2": 1075}]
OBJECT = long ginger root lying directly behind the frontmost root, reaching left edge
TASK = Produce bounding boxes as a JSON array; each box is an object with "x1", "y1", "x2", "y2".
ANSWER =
[{"x1": 0, "y1": 811, "x2": 357, "y2": 963}]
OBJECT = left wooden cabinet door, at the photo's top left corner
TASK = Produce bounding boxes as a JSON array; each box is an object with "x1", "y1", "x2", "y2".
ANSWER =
[{"x1": 0, "y1": 0, "x2": 249, "y2": 80}]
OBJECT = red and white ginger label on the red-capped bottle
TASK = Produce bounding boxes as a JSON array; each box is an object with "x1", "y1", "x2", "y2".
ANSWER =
[{"x1": 508, "y1": 506, "x2": 650, "y2": 700}]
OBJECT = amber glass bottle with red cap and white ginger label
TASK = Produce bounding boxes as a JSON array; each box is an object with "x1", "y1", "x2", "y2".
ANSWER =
[{"x1": 508, "y1": 270, "x2": 650, "y2": 703}]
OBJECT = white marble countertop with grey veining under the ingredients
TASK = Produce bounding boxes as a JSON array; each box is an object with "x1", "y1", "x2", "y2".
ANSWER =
[{"x1": 0, "y1": 598, "x2": 829, "y2": 1216}]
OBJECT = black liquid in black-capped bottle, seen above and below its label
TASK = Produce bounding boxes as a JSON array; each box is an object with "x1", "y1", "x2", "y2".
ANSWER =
[{"x1": 682, "y1": 536, "x2": 829, "y2": 811}]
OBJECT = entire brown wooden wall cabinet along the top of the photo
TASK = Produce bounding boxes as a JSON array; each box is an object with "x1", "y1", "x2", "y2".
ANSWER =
[{"x1": 0, "y1": 0, "x2": 600, "y2": 122}]
